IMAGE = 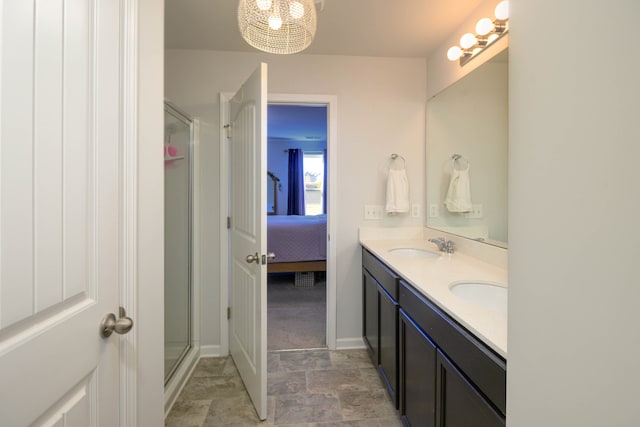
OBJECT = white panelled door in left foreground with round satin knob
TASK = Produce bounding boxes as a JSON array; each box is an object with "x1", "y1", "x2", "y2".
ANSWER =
[{"x1": 0, "y1": 0, "x2": 123, "y2": 427}]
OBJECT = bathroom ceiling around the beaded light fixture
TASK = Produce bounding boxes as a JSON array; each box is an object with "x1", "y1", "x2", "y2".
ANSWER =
[{"x1": 165, "y1": 0, "x2": 483, "y2": 57}]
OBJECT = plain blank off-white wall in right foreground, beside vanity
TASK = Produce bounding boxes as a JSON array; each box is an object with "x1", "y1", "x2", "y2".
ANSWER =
[{"x1": 507, "y1": 0, "x2": 640, "y2": 427}]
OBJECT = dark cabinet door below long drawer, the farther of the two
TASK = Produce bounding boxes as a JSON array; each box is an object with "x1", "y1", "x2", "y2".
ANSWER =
[{"x1": 398, "y1": 309, "x2": 436, "y2": 427}]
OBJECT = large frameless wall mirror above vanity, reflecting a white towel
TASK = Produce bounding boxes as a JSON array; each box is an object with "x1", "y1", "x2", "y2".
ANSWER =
[{"x1": 426, "y1": 49, "x2": 509, "y2": 248}]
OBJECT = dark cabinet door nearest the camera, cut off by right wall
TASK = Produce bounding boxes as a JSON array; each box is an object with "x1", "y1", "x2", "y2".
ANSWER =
[{"x1": 436, "y1": 350, "x2": 505, "y2": 427}]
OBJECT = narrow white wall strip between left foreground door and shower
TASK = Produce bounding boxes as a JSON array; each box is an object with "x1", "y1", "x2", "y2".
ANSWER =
[{"x1": 138, "y1": 0, "x2": 164, "y2": 427}]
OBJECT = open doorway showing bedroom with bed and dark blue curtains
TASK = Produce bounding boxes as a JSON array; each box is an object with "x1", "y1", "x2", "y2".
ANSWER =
[{"x1": 267, "y1": 103, "x2": 330, "y2": 351}]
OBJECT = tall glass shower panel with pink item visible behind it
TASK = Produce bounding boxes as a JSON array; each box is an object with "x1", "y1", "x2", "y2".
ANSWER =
[{"x1": 164, "y1": 103, "x2": 194, "y2": 386}]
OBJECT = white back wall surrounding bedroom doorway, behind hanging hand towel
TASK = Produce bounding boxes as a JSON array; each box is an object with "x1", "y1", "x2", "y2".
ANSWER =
[{"x1": 165, "y1": 50, "x2": 426, "y2": 352}]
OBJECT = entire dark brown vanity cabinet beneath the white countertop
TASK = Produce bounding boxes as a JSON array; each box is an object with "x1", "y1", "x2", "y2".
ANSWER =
[{"x1": 362, "y1": 249, "x2": 507, "y2": 427}]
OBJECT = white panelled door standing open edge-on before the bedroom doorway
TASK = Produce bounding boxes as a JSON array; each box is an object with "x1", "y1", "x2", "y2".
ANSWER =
[{"x1": 229, "y1": 63, "x2": 267, "y2": 419}]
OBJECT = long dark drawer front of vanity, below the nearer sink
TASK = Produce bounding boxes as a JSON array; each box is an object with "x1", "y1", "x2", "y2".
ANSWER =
[{"x1": 398, "y1": 280, "x2": 507, "y2": 415}]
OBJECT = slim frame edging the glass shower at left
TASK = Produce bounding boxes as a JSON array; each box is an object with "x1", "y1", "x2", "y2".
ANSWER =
[{"x1": 164, "y1": 99, "x2": 200, "y2": 415}]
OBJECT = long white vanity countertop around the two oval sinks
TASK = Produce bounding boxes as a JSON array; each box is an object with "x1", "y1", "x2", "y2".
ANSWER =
[{"x1": 360, "y1": 238, "x2": 507, "y2": 359}]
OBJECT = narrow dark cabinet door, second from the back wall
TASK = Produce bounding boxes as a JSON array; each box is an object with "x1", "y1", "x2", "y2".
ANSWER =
[{"x1": 378, "y1": 286, "x2": 398, "y2": 408}]
